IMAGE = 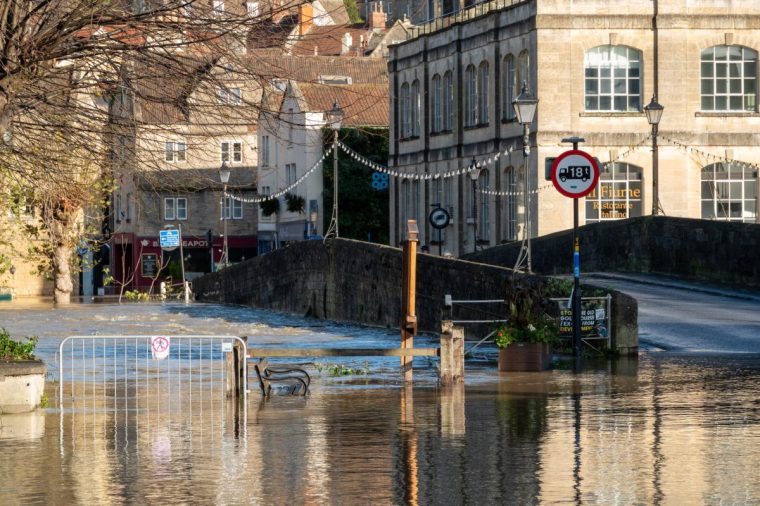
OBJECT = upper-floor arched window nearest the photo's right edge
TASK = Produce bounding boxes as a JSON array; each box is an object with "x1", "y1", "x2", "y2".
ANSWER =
[{"x1": 700, "y1": 46, "x2": 757, "y2": 112}]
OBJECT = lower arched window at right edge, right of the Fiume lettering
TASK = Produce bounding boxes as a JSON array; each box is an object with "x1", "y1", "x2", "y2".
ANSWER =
[{"x1": 702, "y1": 162, "x2": 757, "y2": 223}]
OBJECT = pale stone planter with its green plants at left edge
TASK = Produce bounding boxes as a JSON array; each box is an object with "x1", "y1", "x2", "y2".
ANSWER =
[{"x1": 0, "y1": 329, "x2": 47, "y2": 414}]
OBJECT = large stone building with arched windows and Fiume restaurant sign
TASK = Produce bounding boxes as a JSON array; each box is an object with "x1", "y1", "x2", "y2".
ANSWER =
[{"x1": 389, "y1": 0, "x2": 760, "y2": 255}]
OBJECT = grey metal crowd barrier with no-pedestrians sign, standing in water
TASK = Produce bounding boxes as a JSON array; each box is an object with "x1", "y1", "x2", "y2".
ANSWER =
[{"x1": 57, "y1": 335, "x2": 248, "y2": 412}]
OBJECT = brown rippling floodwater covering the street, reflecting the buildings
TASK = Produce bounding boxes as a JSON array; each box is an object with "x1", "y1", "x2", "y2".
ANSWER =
[{"x1": 0, "y1": 303, "x2": 760, "y2": 505}]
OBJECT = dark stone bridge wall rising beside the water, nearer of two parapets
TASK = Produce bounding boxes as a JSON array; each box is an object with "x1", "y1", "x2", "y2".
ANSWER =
[{"x1": 193, "y1": 239, "x2": 638, "y2": 352}]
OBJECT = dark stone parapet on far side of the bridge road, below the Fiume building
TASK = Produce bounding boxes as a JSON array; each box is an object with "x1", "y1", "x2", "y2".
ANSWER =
[{"x1": 465, "y1": 216, "x2": 760, "y2": 288}]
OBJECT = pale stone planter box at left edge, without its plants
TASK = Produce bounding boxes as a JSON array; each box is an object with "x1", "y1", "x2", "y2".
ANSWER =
[{"x1": 0, "y1": 360, "x2": 47, "y2": 414}]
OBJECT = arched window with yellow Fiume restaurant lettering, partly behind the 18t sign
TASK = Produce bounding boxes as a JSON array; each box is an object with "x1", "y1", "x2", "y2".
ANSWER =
[{"x1": 586, "y1": 163, "x2": 642, "y2": 223}]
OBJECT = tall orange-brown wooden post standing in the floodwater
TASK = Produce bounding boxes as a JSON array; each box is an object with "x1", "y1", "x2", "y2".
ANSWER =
[{"x1": 401, "y1": 220, "x2": 419, "y2": 381}]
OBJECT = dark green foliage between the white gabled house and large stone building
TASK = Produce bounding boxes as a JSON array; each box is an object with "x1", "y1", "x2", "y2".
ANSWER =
[{"x1": 322, "y1": 128, "x2": 389, "y2": 244}]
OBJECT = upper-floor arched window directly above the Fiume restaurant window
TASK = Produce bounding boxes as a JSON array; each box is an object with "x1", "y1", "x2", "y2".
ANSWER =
[{"x1": 583, "y1": 45, "x2": 641, "y2": 112}]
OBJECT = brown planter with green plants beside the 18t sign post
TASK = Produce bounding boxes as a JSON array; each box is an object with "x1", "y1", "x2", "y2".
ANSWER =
[{"x1": 494, "y1": 281, "x2": 559, "y2": 371}]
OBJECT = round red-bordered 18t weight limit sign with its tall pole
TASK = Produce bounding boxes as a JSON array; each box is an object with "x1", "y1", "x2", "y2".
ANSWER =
[{"x1": 551, "y1": 137, "x2": 600, "y2": 359}]
